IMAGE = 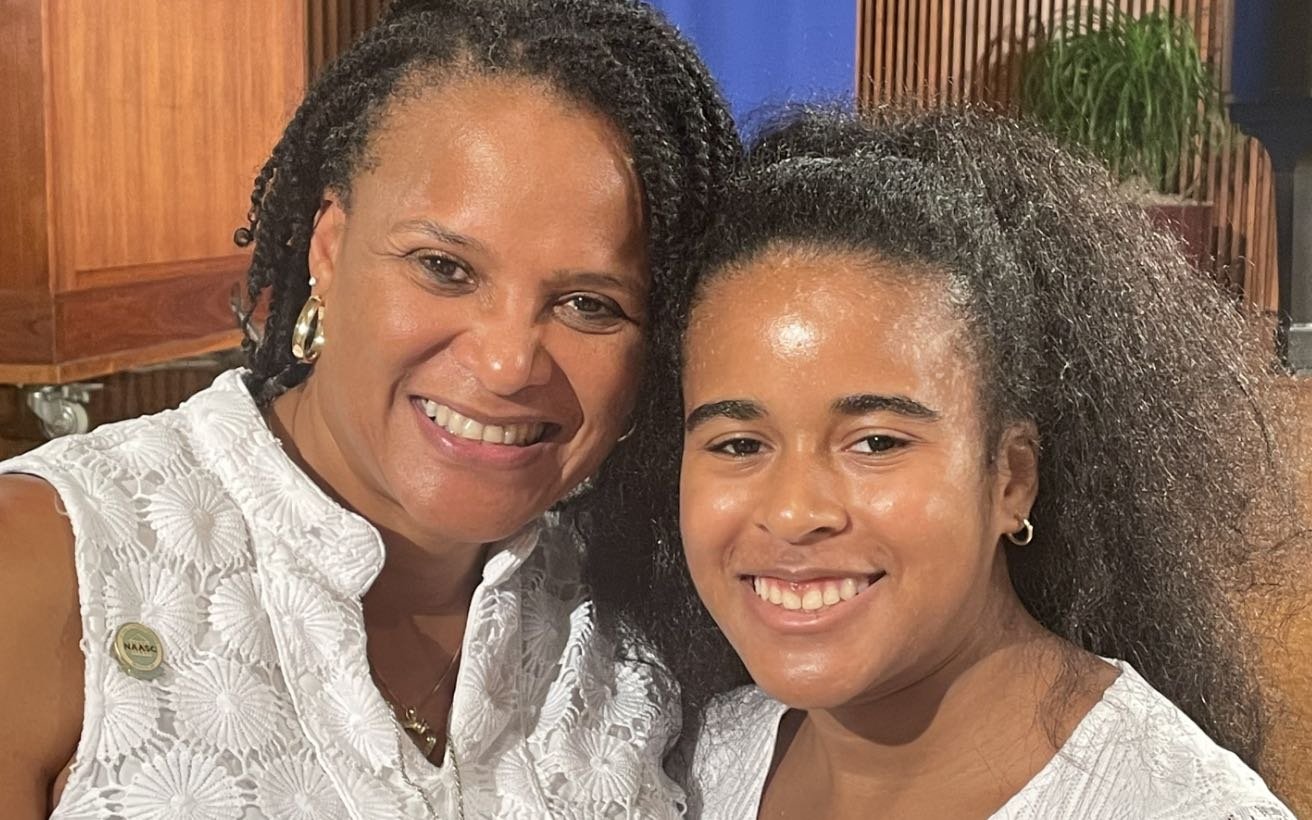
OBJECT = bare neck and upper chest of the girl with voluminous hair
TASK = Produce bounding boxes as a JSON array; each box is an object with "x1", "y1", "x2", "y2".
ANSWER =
[{"x1": 761, "y1": 601, "x2": 1115, "y2": 817}]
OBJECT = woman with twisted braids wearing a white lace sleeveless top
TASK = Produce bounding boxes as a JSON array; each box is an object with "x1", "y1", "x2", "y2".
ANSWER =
[{"x1": 0, "y1": 0, "x2": 737, "y2": 819}]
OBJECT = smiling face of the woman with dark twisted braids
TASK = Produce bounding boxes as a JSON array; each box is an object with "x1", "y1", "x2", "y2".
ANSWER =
[{"x1": 299, "y1": 77, "x2": 648, "y2": 543}]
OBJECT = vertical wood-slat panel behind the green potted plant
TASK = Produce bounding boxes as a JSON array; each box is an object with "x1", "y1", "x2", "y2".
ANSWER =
[{"x1": 857, "y1": 0, "x2": 1279, "y2": 312}]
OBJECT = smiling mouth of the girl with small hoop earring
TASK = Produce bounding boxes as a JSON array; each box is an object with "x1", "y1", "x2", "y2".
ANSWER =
[{"x1": 740, "y1": 572, "x2": 884, "y2": 635}]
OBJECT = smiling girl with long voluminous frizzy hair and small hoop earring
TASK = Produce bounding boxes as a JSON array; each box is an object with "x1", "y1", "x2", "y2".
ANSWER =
[{"x1": 594, "y1": 106, "x2": 1291, "y2": 820}]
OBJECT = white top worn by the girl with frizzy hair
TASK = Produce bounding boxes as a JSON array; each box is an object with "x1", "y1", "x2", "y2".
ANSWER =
[{"x1": 687, "y1": 660, "x2": 1295, "y2": 820}]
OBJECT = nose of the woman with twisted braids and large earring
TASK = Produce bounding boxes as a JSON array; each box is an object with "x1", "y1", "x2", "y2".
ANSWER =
[{"x1": 458, "y1": 310, "x2": 552, "y2": 396}]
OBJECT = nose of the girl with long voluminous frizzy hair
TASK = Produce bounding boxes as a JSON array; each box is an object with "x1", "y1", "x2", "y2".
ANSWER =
[{"x1": 758, "y1": 458, "x2": 848, "y2": 544}]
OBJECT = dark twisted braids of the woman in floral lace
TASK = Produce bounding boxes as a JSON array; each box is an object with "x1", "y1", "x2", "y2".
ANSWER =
[{"x1": 236, "y1": 0, "x2": 741, "y2": 404}]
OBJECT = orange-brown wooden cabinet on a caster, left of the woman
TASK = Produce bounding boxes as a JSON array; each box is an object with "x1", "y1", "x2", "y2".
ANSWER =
[{"x1": 0, "y1": 0, "x2": 306, "y2": 383}]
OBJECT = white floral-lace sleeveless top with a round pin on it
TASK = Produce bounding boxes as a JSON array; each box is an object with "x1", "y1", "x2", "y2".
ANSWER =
[{"x1": 0, "y1": 371, "x2": 682, "y2": 820}]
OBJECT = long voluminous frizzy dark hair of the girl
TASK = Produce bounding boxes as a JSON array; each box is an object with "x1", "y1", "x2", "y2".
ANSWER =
[{"x1": 579, "y1": 110, "x2": 1294, "y2": 765}]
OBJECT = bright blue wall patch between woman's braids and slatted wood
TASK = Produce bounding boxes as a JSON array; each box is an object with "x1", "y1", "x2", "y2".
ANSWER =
[{"x1": 648, "y1": 0, "x2": 857, "y2": 131}]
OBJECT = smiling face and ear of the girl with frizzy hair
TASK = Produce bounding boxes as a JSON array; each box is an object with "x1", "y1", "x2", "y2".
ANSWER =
[{"x1": 681, "y1": 248, "x2": 1035, "y2": 708}]
